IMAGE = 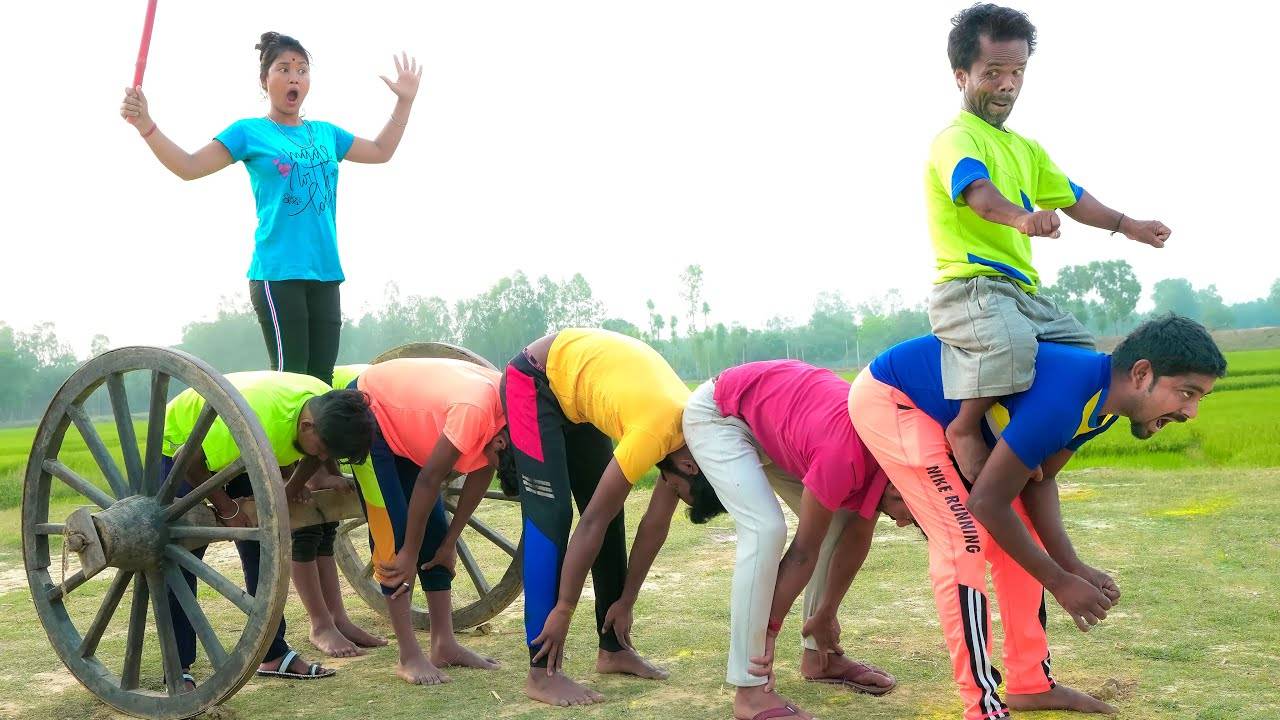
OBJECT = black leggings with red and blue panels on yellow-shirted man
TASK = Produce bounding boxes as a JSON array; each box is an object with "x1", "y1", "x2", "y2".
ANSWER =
[{"x1": 502, "y1": 354, "x2": 627, "y2": 667}]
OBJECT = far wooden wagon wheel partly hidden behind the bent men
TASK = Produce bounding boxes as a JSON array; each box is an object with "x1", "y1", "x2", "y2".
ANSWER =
[{"x1": 334, "y1": 342, "x2": 521, "y2": 630}]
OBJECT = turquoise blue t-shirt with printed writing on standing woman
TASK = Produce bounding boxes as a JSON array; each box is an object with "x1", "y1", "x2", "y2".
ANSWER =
[{"x1": 214, "y1": 118, "x2": 355, "y2": 281}]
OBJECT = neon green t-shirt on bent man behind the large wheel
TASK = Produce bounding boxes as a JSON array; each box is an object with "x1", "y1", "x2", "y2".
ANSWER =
[{"x1": 164, "y1": 370, "x2": 330, "y2": 473}]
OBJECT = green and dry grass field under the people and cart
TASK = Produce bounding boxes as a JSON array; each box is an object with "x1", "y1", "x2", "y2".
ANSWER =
[{"x1": 0, "y1": 351, "x2": 1280, "y2": 720}]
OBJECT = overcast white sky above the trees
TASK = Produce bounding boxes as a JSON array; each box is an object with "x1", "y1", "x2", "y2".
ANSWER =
[{"x1": 0, "y1": 0, "x2": 1280, "y2": 354}]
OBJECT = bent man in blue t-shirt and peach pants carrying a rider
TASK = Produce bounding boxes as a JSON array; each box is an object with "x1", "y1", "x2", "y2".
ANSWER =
[{"x1": 849, "y1": 315, "x2": 1226, "y2": 720}]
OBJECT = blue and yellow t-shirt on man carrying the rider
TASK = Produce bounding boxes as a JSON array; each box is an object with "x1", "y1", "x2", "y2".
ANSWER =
[{"x1": 870, "y1": 336, "x2": 1116, "y2": 468}]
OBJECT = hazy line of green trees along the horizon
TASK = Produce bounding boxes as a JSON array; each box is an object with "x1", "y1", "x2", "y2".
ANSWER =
[{"x1": 0, "y1": 260, "x2": 1280, "y2": 423}]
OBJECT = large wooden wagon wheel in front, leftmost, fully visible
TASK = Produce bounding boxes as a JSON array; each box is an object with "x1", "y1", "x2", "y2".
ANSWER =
[{"x1": 22, "y1": 347, "x2": 289, "y2": 719}]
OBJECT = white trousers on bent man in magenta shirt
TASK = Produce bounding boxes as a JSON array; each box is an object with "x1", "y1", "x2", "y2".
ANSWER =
[{"x1": 684, "y1": 380, "x2": 850, "y2": 687}]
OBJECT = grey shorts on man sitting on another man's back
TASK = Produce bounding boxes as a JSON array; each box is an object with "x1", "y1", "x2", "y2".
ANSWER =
[{"x1": 929, "y1": 275, "x2": 1094, "y2": 400}]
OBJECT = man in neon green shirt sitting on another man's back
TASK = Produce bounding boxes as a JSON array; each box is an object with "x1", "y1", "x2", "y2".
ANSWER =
[{"x1": 925, "y1": 4, "x2": 1170, "y2": 486}]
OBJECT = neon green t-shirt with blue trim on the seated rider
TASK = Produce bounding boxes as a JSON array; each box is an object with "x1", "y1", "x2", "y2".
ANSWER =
[{"x1": 924, "y1": 111, "x2": 1084, "y2": 292}]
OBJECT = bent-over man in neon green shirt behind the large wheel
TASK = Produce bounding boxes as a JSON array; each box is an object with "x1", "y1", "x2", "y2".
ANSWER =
[{"x1": 164, "y1": 370, "x2": 373, "y2": 688}]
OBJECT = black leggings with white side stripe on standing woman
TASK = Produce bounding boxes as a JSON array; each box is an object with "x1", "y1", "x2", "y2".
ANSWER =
[{"x1": 248, "y1": 281, "x2": 342, "y2": 384}]
